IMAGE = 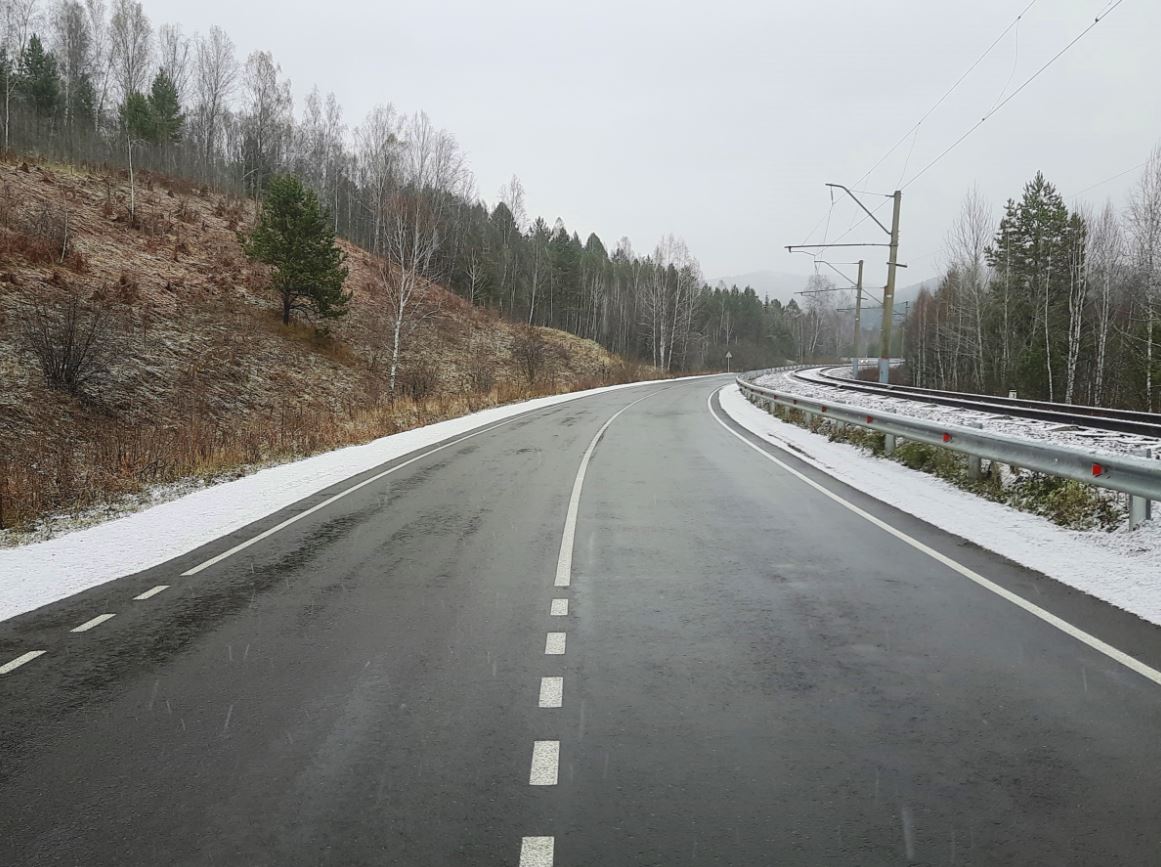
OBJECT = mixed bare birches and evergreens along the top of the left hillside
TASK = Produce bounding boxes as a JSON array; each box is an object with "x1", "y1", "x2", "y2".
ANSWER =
[{"x1": 0, "y1": 0, "x2": 798, "y2": 376}]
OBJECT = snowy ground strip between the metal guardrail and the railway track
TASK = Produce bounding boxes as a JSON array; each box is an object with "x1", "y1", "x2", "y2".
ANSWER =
[{"x1": 755, "y1": 368, "x2": 1161, "y2": 457}]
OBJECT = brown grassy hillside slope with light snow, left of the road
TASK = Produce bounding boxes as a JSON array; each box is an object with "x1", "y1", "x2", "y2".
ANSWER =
[{"x1": 0, "y1": 155, "x2": 654, "y2": 542}]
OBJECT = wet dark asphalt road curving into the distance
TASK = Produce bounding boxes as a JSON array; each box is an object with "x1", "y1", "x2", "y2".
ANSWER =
[{"x1": 0, "y1": 378, "x2": 1161, "y2": 867}]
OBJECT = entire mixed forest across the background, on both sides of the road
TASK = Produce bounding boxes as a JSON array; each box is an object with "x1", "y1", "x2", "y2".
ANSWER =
[{"x1": 0, "y1": 0, "x2": 1161, "y2": 410}]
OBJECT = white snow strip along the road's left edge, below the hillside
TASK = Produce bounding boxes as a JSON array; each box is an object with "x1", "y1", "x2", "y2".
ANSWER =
[{"x1": 0, "y1": 380, "x2": 675, "y2": 621}]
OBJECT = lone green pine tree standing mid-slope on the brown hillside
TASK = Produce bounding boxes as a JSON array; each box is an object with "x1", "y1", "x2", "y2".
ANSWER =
[{"x1": 243, "y1": 175, "x2": 351, "y2": 324}]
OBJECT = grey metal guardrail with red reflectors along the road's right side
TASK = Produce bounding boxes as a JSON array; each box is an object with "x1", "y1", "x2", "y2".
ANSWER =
[{"x1": 736, "y1": 366, "x2": 1161, "y2": 526}]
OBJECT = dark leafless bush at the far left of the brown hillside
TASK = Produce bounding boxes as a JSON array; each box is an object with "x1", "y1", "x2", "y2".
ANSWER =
[{"x1": 21, "y1": 294, "x2": 113, "y2": 395}]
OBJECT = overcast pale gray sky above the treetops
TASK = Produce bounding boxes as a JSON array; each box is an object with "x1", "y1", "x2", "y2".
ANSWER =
[{"x1": 144, "y1": 0, "x2": 1161, "y2": 290}]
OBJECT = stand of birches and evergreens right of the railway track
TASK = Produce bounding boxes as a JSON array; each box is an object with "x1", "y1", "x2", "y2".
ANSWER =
[{"x1": 904, "y1": 154, "x2": 1161, "y2": 412}]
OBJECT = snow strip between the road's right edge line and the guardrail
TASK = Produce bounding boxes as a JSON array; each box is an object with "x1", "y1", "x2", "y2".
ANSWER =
[{"x1": 720, "y1": 385, "x2": 1161, "y2": 624}]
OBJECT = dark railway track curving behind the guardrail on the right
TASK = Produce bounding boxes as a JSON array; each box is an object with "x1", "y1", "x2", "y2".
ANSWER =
[{"x1": 793, "y1": 368, "x2": 1161, "y2": 439}]
